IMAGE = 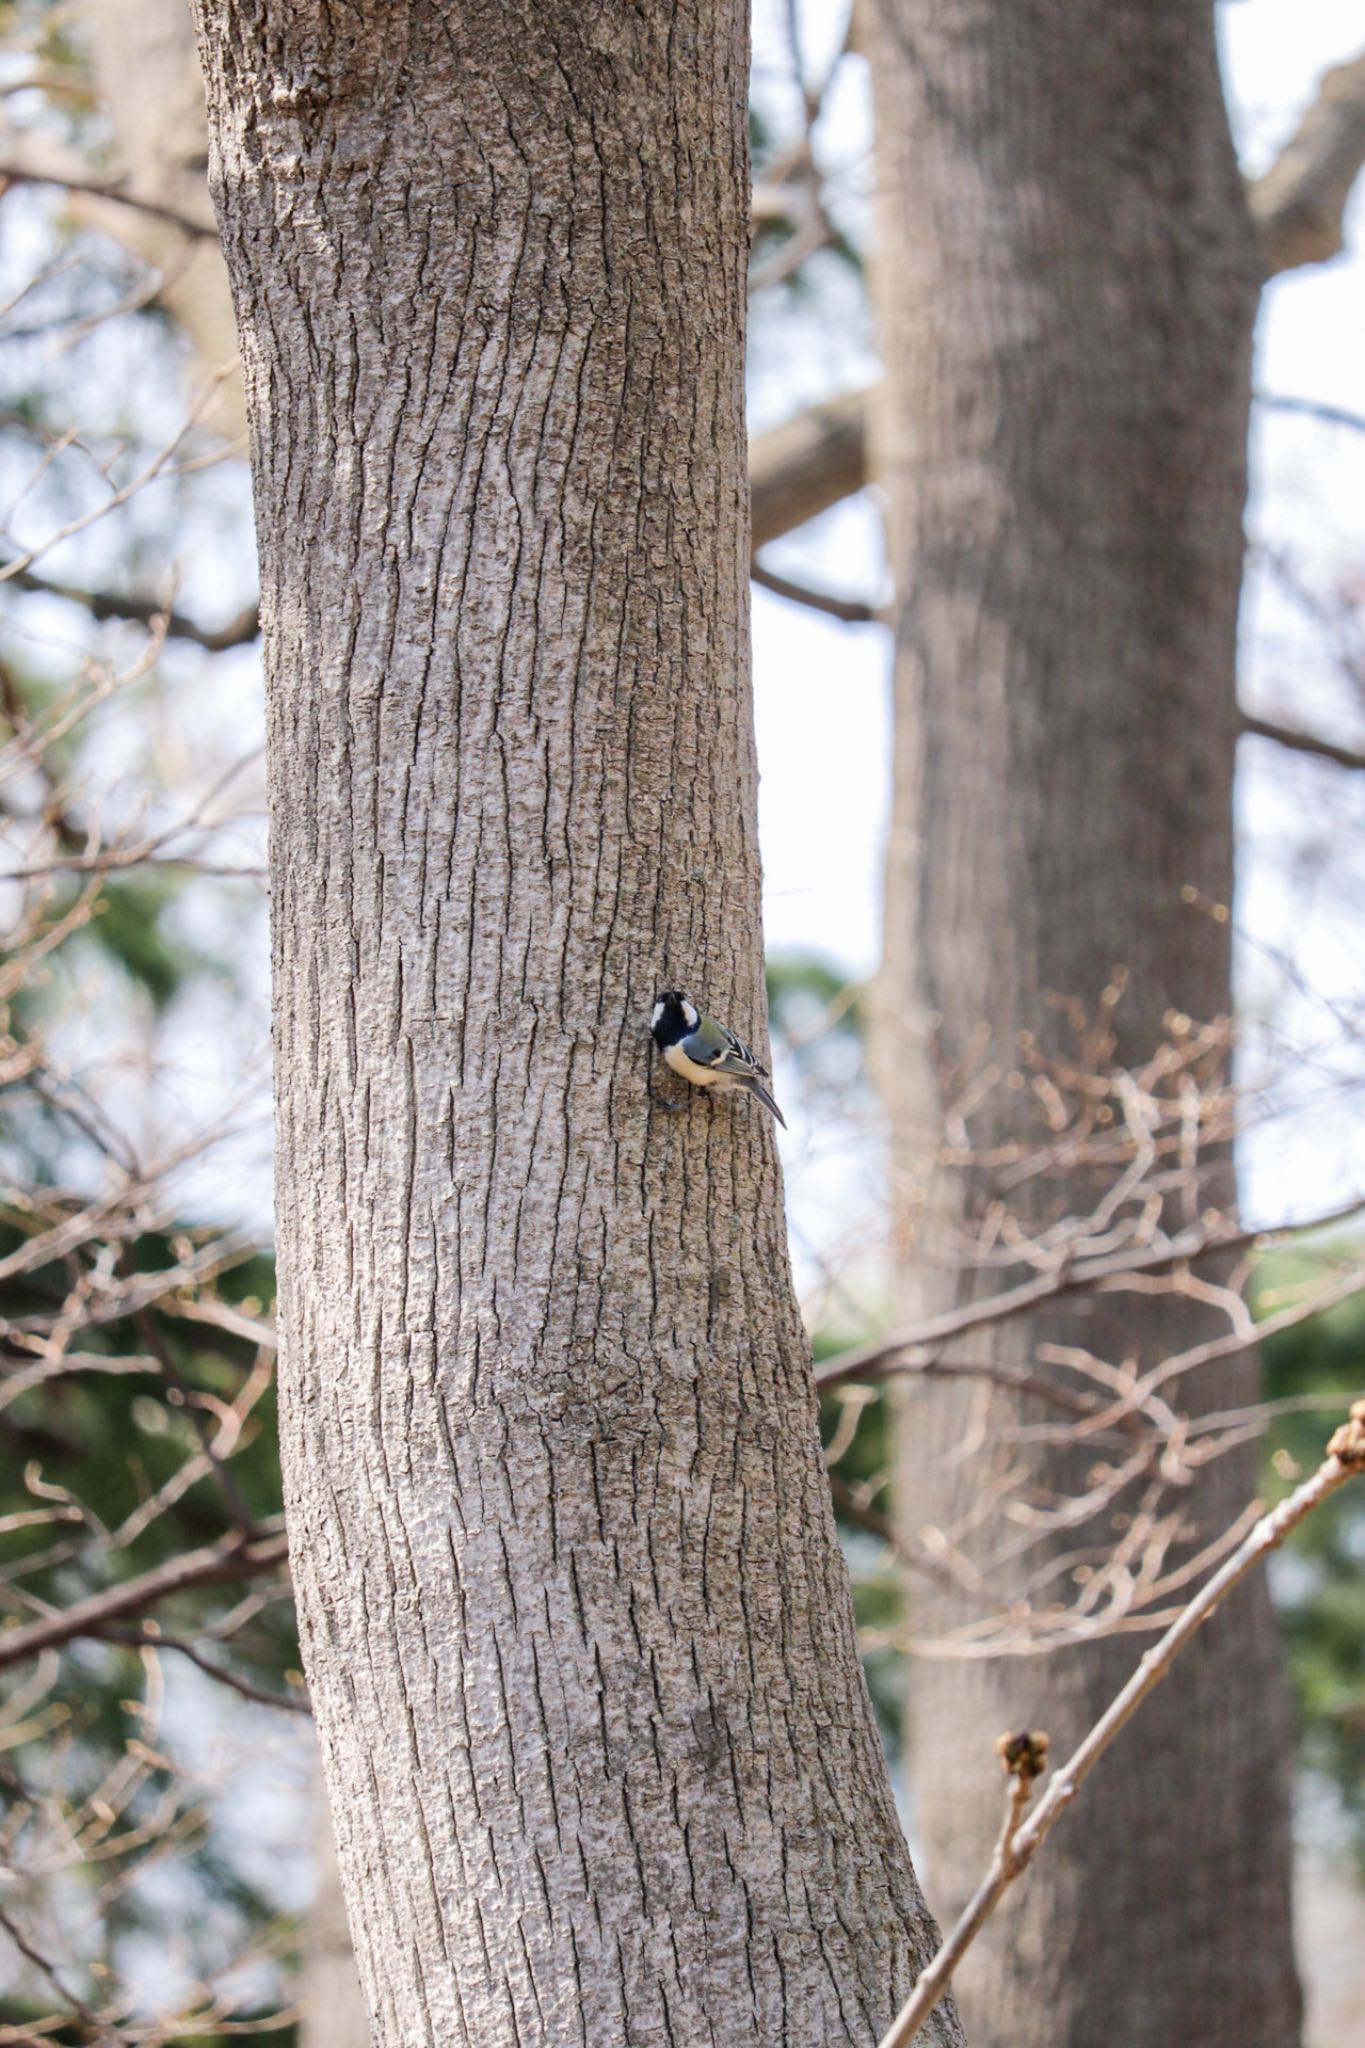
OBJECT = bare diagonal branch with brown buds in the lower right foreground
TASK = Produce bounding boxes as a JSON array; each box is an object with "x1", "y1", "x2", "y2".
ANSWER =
[{"x1": 880, "y1": 1401, "x2": 1365, "y2": 2048}]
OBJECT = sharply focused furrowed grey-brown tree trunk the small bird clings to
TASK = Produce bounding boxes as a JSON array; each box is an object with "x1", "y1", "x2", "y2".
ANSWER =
[{"x1": 201, "y1": 0, "x2": 960, "y2": 2048}]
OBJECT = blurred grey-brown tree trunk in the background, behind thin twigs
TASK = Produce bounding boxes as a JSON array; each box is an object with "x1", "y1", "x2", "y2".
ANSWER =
[{"x1": 864, "y1": 0, "x2": 1300, "y2": 2048}]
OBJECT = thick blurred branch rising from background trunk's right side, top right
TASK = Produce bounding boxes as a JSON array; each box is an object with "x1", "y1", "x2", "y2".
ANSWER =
[{"x1": 1246, "y1": 53, "x2": 1365, "y2": 276}]
